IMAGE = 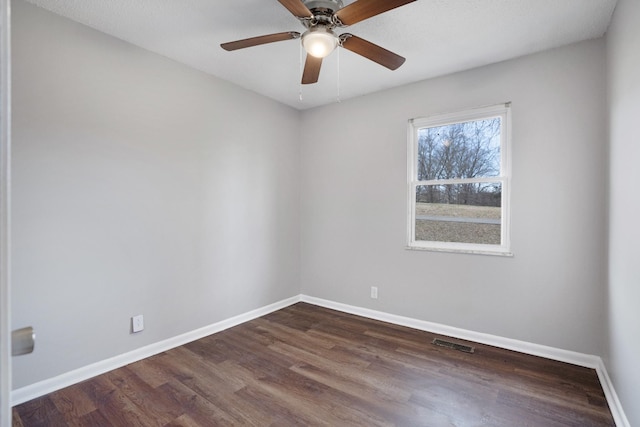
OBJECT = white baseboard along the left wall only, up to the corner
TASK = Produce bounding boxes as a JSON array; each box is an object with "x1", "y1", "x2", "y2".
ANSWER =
[{"x1": 11, "y1": 295, "x2": 300, "y2": 406}]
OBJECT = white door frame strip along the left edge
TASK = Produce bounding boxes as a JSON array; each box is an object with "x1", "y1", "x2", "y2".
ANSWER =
[{"x1": 0, "y1": 0, "x2": 11, "y2": 427}]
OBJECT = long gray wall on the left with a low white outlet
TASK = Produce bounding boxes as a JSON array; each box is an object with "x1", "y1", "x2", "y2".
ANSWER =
[{"x1": 12, "y1": 1, "x2": 300, "y2": 388}]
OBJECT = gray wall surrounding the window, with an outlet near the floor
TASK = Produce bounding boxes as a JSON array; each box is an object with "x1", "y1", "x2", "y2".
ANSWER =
[{"x1": 301, "y1": 40, "x2": 607, "y2": 354}]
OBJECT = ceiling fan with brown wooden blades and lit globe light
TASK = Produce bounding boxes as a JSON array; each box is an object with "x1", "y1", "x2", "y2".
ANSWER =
[{"x1": 220, "y1": 0, "x2": 416, "y2": 84}]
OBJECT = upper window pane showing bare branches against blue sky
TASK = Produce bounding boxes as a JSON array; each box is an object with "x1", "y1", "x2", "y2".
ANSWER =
[{"x1": 417, "y1": 117, "x2": 501, "y2": 181}]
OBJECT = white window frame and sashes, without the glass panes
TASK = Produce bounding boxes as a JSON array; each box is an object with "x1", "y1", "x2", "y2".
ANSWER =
[{"x1": 407, "y1": 103, "x2": 513, "y2": 256}]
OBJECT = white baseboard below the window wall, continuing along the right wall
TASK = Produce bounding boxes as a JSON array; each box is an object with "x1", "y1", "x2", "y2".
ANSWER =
[{"x1": 300, "y1": 295, "x2": 631, "y2": 427}]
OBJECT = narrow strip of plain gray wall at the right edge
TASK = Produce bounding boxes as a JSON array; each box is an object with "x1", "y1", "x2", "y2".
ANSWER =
[{"x1": 607, "y1": 0, "x2": 640, "y2": 426}]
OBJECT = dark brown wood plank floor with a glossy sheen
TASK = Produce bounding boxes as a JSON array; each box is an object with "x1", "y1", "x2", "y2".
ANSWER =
[{"x1": 13, "y1": 303, "x2": 615, "y2": 427}]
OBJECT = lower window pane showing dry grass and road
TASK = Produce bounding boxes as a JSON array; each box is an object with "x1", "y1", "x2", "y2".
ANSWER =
[{"x1": 415, "y1": 182, "x2": 502, "y2": 245}]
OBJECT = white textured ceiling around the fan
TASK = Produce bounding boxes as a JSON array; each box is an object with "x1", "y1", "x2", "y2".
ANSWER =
[{"x1": 22, "y1": 0, "x2": 616, "y2": 109}]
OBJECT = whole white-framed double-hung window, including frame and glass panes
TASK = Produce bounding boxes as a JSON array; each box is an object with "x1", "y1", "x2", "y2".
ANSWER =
[{"x1": 407, "y1": 104, "x2": 510, "y2": 255}]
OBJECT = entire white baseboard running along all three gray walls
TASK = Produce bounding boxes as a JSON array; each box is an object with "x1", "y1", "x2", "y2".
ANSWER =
[{"x1": 11, "y1": 295, "x2": 630, "y2": 427}]
